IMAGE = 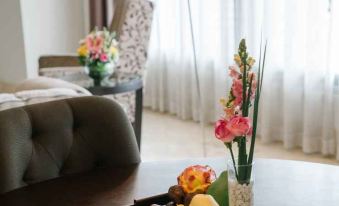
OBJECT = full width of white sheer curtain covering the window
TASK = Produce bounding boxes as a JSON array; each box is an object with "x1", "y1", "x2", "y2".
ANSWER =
[{"x1": 145, "y1": 0, "x2": 339, "y2": 159}]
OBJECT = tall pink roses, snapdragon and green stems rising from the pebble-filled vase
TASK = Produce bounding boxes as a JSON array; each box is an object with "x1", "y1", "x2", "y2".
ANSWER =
[{"x1": 215, "y1": 39, "x2": 266, "y2": 184}]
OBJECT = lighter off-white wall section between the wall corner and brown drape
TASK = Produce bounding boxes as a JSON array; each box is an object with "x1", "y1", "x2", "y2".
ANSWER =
[{"x1": 21, "y1": 0, "x2": 86, "y2": 77}]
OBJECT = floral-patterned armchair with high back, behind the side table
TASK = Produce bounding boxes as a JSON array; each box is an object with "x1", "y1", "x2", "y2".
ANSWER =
[{"x1": 39, "y1": 0, "x2": 153, "y2": 142}]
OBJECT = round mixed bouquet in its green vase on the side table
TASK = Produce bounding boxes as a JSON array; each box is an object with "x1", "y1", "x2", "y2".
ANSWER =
[{"x1": 77, "y1": 28, "x2": 119, "y2": 84}]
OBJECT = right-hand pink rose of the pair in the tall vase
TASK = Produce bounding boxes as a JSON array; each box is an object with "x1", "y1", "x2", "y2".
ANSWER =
[{"x1": 226, "y1": 116, "x2": 251, "y2": 136}]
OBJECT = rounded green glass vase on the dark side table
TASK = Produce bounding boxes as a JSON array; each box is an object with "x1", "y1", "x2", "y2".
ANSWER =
[{"x1": 85, "y1": 62, "x2": 115, "y2": 86}]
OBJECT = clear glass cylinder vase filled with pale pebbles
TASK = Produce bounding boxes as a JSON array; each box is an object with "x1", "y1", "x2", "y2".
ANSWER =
[{"x1": 227, "y1": 160, "x2": 255, "y2": 206}]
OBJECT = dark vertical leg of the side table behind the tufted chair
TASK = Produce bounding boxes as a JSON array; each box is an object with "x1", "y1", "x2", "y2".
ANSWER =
[{"x1": 134, "y1": 88, "x2": 143, "y2": 151}]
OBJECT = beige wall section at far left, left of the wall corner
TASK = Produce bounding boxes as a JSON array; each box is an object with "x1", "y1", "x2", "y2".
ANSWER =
[{"x1": 0, "y1": 0, "x2": 27, "y2": 83}]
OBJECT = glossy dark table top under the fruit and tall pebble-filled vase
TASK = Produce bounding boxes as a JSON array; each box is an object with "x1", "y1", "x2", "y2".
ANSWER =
[{"x1": 0, "y1": 158, "x2": 339, "y2": 206}]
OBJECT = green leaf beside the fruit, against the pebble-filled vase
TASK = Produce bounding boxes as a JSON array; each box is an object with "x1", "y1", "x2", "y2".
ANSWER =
[{"x1": 207, "y1": 171, "x2": 228, "y2": 206}]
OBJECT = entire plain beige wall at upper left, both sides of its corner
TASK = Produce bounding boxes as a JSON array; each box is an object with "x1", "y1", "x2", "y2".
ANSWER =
[{"x1": 0, "y1": 0, "x2": 89, "y2": 82}]
